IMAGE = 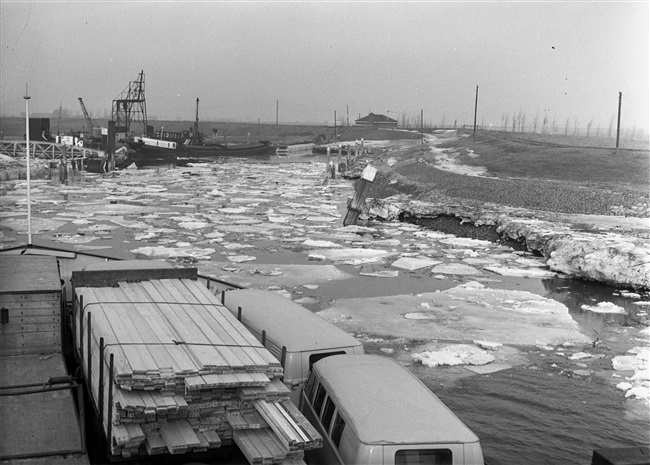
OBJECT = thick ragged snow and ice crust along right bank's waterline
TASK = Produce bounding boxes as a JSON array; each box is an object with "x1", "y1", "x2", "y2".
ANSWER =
[{"x1": 362, "y1": 195, "x2": 650, "y2": 289}]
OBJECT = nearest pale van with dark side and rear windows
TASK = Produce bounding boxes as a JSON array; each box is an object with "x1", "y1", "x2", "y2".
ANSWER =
[{"x1": 300, "y1": 355, "x2": 483, "y2": 465}]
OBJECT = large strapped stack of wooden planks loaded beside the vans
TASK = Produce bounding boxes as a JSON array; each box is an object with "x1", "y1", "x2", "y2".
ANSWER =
[{"x1": 73, "y1": 279, "x2": 322, "y2": 463}]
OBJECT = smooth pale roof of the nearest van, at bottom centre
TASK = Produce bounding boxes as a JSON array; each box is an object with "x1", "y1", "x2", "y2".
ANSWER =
[{"x1": 313, "y1": 355, "x2": 479, "y2": 444}]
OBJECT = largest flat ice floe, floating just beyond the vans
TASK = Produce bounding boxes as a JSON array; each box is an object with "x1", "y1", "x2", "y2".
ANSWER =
[{"x1": 318, "y1": 281, "x2": 590, "y2": 345}]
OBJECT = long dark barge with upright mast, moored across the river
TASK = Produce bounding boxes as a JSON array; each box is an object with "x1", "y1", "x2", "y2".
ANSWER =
[{"x1": 127, "y1": 98, "x2": 273, "y2": 163}]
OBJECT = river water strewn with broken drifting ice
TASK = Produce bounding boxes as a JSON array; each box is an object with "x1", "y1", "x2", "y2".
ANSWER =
[{"x1": 0, "y1": 158, "x2": 650, "y2": 464}]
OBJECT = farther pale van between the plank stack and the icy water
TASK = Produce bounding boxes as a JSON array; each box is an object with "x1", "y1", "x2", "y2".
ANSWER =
[{"x1": 223, "y1": 289, "x2": 364, "y2": 406}]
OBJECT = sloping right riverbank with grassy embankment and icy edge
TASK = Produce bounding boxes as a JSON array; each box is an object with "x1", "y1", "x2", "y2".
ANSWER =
[{"x1": 354, "y1": 131, "x2": 650, "y2": 290}]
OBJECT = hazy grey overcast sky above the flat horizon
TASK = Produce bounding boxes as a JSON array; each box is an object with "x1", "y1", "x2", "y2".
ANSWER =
[{"x1": 0, "y1": 0, "x2": 650, "y2": 134}]
